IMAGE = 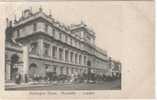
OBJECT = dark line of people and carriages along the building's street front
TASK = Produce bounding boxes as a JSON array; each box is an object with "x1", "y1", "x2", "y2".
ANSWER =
[{"x1": 16, "y1": 72, "x2": 121, "y2": 84}]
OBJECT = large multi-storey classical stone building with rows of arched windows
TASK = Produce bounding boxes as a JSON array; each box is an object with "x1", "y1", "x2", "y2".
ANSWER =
[{"x1": 5, "y1": 8, "x2": 120, "y2": 81}]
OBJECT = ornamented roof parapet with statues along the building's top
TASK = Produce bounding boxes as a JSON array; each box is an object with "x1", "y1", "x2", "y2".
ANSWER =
[{"x1": 13, "y1": 8, "x2": 95, "y2": 35}]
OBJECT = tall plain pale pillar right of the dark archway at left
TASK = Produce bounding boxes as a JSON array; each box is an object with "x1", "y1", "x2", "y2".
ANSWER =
[{"x1": 22, "y1": 46, "x2": 29, "y2": 82}]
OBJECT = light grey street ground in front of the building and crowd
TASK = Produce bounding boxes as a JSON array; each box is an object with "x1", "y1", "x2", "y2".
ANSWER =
[{"x1": 5, "y1": 80, "x2": 121, "y2": 90}]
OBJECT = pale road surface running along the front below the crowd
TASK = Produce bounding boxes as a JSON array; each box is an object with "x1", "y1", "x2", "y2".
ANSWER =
[{"x1": 6, "y1": 79, "x2": 121, "y2": 90}]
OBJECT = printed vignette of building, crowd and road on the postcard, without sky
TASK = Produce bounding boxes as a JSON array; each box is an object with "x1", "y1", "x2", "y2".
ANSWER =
[{"x1": 5, "y1": 4, "x2": 122, "y2": 90}]
